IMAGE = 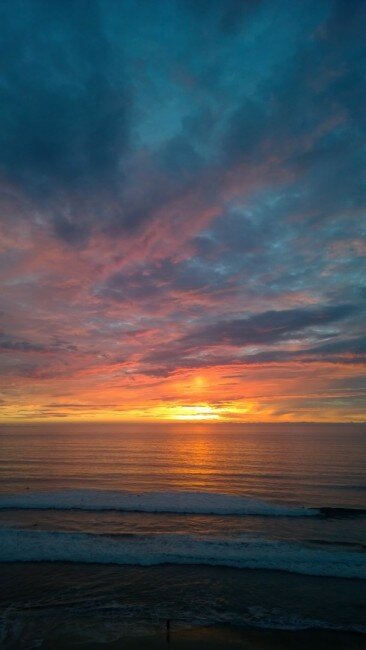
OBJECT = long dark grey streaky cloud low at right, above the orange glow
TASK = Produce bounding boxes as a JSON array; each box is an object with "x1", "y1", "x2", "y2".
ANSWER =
[{"x1": 143, "y1": 305, "x2": 365, "y2": 374}]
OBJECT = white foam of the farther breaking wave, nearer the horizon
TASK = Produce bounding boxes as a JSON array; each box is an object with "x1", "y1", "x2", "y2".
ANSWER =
[{"x1": 0, "y1": 490, "x2": 319, "y2": 517}]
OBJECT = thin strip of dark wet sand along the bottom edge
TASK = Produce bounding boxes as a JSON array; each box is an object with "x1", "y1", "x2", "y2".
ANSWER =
[{"x1": 40, "y1": 626, "x2": 366, "y2": 650}]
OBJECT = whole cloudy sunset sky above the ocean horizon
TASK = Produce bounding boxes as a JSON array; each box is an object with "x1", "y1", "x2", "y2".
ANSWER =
[{"x1": 0, "y1": 0, "x2": 366, "y2": 422}]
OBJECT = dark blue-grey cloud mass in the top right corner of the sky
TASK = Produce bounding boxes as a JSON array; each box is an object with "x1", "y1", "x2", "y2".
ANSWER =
[{"x1": 222, "y1": 2, "x2": 366, "y2": 220}]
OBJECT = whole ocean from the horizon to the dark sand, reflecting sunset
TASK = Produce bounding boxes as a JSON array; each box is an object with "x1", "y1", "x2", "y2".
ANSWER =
[{"x1": 0, "y1": 423, "x2": 366, "y2": 648}]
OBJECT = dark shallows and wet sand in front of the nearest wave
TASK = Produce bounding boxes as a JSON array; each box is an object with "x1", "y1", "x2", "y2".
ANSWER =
[{"x1": 0, "y1": 562, "x2": 366, "y2": 650}]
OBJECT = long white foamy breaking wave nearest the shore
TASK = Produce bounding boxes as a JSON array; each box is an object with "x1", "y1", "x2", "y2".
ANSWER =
[{"x1": 0, "y1": 529, "x2": 366, "y2": 578}]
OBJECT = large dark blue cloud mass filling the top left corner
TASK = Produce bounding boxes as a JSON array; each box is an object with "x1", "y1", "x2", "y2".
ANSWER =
[{"x1": 0, "y1": 0, "x2": 128, "y2": 192}]
